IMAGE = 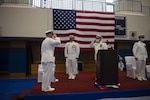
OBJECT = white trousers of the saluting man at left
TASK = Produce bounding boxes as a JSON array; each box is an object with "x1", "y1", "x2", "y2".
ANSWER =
[{"x1": 41, "y1": 62, "x2": 55, "y2": 90}]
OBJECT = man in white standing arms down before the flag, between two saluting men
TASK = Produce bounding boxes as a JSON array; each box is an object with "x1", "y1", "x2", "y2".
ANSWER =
[{"x1": 64, "y1": 35, "x2": 80, "y2": 79}]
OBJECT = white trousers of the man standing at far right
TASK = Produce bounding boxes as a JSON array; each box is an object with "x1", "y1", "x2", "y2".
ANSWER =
[{"x1": 136, "y1": 60, "x2": 146, "y2": 78}]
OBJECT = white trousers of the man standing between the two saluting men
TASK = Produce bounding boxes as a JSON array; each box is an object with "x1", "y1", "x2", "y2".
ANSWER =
[{"x1": 66, "y1": 59, "x2": 78, "y2": 75}]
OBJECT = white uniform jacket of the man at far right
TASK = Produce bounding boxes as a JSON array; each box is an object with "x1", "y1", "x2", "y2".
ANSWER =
[{"x1": 132, "y1": 41, "x2": 148, "y2": 60}]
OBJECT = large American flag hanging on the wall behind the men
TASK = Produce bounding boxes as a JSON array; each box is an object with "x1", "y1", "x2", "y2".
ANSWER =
[{"x1": 53, "y1": 9, "x2": 115, "y2": 50}]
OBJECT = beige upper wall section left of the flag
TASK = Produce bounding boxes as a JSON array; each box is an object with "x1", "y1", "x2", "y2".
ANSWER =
[{"x1": 0, "y1": 7, "x2": 52, "y2": 37}]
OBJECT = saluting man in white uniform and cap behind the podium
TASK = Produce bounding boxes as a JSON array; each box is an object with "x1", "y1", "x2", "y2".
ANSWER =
[{"x1": 90, "y1": 34, "x2": 108, "y2": 62}]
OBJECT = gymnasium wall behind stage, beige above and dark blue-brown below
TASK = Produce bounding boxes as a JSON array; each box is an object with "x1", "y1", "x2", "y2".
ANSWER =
[{"x1": 0, "y1": 4, "x2": 150, "y2": 74}]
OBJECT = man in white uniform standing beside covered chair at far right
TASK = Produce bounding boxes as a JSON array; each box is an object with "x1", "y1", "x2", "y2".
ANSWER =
[{"x1": 132, "y1": 35, "x2": 148, "y2": 81}]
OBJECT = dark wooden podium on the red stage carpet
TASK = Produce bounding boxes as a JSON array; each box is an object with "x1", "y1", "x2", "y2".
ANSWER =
[{"x1": 96, "y1": 50, "x2": 118, "y2": 85}]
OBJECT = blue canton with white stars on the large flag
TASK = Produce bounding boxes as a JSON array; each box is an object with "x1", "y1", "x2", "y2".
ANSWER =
[{"x1": 53, "y1": 9, "x2": 76, "y2": 30}]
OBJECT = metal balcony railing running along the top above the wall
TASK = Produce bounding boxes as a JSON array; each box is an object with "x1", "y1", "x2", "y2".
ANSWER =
[{"x1": 0, "y1": 0, "x2": 150, "y2": 16}]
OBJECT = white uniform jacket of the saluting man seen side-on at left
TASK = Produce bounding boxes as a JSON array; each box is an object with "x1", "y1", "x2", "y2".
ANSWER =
[{"x1": 41, "y1": 37, "x2": 61, "y2": 62}]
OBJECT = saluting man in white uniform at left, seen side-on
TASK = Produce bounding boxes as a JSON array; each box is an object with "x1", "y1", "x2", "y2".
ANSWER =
[{"x1": 41, "y1": 30, "x2": 61, "y2": 92}]
